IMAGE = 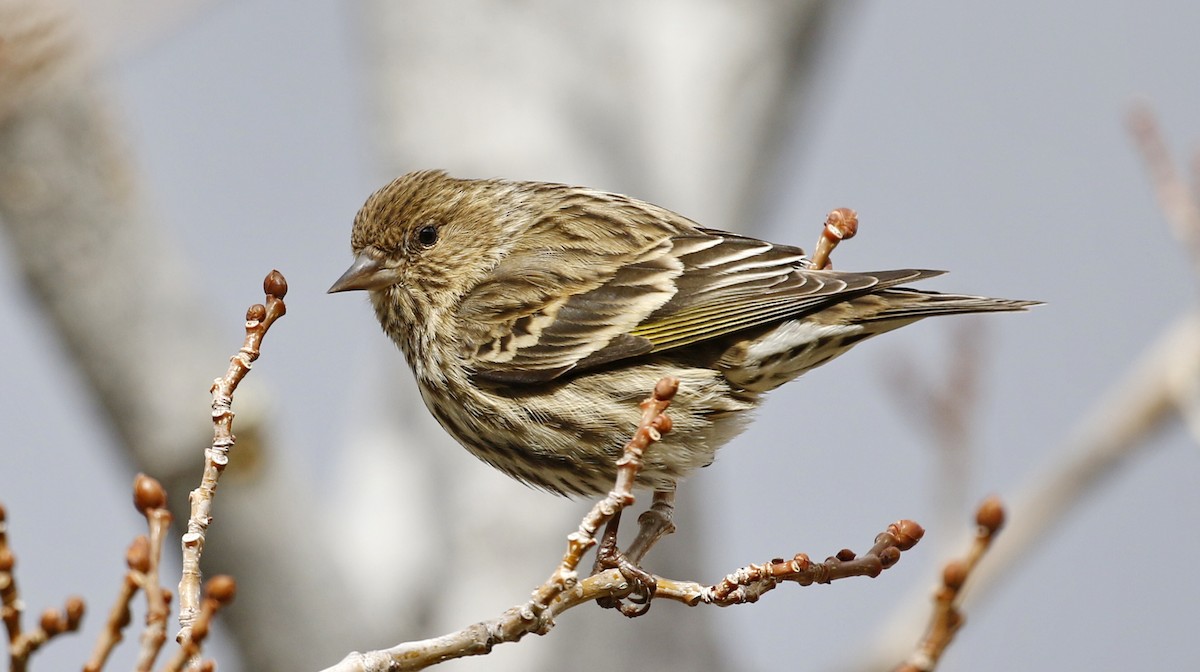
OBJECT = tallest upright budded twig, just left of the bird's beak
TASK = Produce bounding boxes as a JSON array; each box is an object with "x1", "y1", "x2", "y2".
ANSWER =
[{"x1": 176, "y1": 271, "x2": 288, "y2": 642}]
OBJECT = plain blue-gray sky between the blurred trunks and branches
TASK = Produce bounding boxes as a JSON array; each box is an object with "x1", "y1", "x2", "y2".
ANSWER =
[{"x1": 0, "y1": 0, "x2": 1200, "y2": 671}]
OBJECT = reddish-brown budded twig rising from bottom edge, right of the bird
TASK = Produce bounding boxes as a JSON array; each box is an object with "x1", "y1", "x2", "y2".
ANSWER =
[{"x1": 895, "y1": 497, "x2": 1004, "y2": 672}]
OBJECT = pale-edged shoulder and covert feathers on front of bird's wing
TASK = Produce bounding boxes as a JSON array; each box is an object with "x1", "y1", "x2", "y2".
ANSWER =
[{"x1": 457, "y1": 216, "x2": 684, "y2": 384}]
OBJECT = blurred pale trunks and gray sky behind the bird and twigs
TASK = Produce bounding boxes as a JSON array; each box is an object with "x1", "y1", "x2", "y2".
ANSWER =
[{"x1": 0, "y1": 0, "x2": 1200, "y2": 671}]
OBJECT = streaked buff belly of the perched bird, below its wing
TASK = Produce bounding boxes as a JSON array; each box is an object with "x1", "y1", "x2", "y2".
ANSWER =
[{"x1": 412, "y1": 361, "x2": 757, "y2": 496}]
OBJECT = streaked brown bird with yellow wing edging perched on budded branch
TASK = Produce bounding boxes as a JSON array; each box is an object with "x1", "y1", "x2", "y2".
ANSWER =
[{"x1": 329, "y1": 170, "x2": 1036, "y2": 494}]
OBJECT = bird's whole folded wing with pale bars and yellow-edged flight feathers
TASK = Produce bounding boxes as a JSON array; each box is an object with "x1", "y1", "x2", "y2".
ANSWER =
[{"x1": 458, "y1": 223, "x2": 938, "y2": 384}]
